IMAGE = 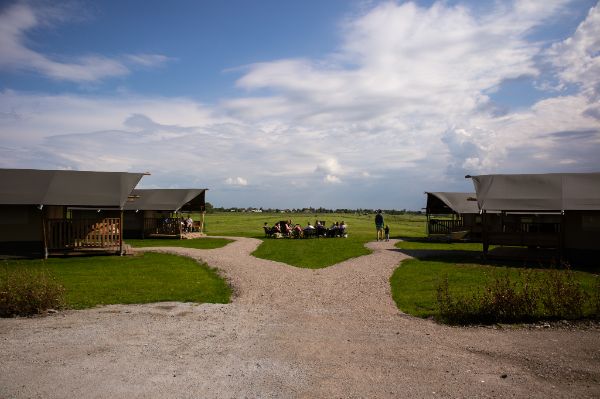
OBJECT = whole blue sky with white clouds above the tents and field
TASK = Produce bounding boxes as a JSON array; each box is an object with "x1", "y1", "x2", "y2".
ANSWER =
[{"x1": 0, "y1": 0, "x2": 600, "y2": 210}]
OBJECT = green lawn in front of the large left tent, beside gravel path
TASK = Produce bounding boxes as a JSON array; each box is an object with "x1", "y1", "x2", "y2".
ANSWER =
[{"x1": 0, "y1": 253, "x2": 231, "y2": 309}]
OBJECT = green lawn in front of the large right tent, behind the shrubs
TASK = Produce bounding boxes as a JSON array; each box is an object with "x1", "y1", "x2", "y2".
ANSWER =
[{"x1": 390, "y1": 256, "x2": 599, "y2": 317}]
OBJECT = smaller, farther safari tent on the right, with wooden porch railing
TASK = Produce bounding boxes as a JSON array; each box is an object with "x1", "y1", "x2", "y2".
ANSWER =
[{"x1": 425, "y1": 192, "x2": 481, "y2": 239}]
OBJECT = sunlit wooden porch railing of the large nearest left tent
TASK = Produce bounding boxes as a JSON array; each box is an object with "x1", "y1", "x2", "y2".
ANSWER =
[{"x1": 46, "y1": 218, "x2": 121, "y2": 250}]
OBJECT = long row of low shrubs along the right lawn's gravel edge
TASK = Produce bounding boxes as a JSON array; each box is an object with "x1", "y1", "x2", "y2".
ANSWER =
[{"x1": 437, "y1": 268, "x2": 600, "y2": 324}]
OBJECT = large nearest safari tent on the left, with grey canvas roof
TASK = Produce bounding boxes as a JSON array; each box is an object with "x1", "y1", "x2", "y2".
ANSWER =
[{"x1": 0, "y1": 169, "x2": 144, "y2": 257}]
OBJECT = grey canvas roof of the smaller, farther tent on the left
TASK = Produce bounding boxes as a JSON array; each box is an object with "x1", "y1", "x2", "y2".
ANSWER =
[{"x1": 125, "y1": 188, "x2": 206, "y2": 212}]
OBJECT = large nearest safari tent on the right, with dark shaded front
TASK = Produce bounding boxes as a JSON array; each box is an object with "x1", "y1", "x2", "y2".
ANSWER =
[{"x1": 467, "y1": 173, "x2": 600, "y2": 255}]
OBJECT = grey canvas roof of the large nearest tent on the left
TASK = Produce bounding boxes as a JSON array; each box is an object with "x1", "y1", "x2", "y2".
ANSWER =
[{"x1": 0, "y1": 169, "x2": 146, "y2": 209}]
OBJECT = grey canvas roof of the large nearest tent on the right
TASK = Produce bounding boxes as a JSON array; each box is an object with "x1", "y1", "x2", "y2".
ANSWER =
[{"x1": 467, "y1": 173, "x2": 600, "y2": 211}]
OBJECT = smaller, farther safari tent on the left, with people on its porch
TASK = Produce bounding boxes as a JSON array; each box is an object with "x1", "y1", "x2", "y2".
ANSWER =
[{"x1": 124, "y1": 189, "x2": 207, "y2": 238}]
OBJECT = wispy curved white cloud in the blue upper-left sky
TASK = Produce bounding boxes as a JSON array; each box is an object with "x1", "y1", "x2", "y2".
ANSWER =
[{"x1": 0, "y1": 2, "x2": 169, "y2": 83}]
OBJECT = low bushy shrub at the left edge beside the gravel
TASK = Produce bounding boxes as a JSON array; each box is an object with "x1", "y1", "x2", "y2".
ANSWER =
[{"x1": 0, "y1": 269, "x2": 65, "y2": 317}]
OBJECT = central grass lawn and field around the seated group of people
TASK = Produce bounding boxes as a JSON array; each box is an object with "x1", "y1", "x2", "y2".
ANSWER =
[{"x1": 195, "y1": 212, "x2": 426, "y2": 269}]
